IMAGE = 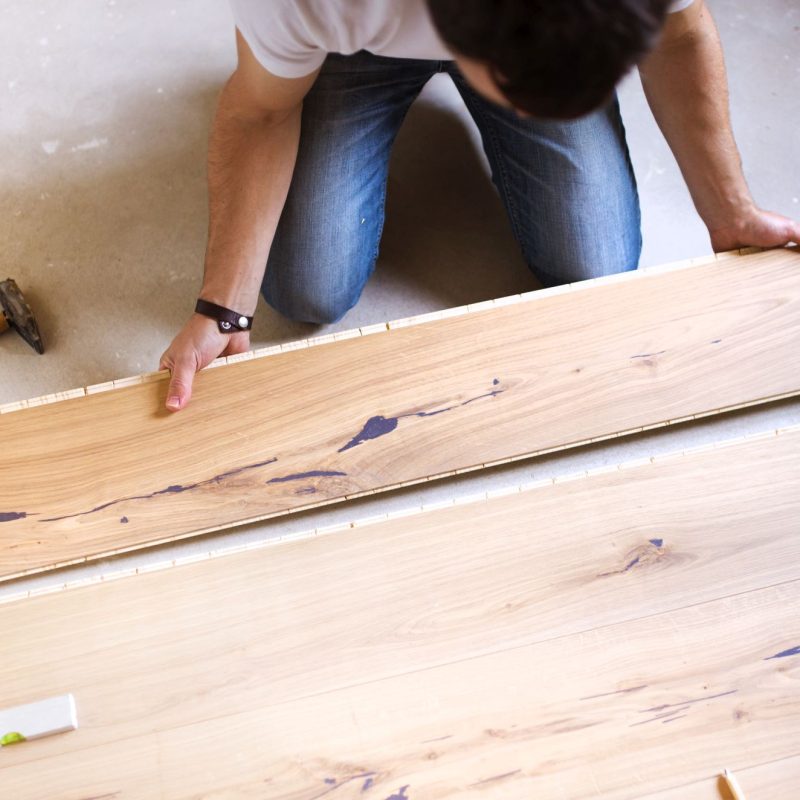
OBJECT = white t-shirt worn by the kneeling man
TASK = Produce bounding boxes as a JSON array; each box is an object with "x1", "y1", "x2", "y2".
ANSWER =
[{"x1": 230, "y1": 0, "x2": 694, "y2": 78}]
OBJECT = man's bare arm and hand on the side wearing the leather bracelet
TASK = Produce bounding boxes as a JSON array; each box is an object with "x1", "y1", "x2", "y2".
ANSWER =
[{"x1": 156, "y1": 31, "x2": 319, "y2": 411}]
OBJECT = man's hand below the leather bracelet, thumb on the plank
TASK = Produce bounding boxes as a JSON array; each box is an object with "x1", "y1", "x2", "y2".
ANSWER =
[{"x1": 159, "y1": 314, "x2": 250, "y2": 411}]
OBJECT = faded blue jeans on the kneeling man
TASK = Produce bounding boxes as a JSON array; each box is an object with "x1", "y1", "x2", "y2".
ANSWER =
[{"x1": 262, "y1": 51, "x2": 642, "y2": 324}]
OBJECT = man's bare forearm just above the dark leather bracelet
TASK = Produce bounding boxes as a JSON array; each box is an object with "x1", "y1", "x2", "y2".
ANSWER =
[{"x1": 201, "y1": 81, "x2": 301, "y2": 315}]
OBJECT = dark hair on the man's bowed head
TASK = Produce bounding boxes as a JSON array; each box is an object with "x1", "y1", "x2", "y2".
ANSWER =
[{"x1": 428, "y1": 0, "x2": 670, "y2": 119}]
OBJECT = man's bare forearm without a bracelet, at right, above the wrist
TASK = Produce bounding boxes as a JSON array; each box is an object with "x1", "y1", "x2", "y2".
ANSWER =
[{"x1": 640, "y1": 5, "x2": 753, "y2": 231}]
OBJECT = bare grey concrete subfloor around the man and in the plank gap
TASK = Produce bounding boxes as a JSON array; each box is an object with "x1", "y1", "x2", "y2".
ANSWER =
[{"x1": 0, "y1": 0, "x2": 800, "y2": 597}]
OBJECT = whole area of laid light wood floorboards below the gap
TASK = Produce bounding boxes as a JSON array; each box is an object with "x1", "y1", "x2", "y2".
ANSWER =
[{"x1": 0, "y1": 429, "x2": 800, "y2": 800}]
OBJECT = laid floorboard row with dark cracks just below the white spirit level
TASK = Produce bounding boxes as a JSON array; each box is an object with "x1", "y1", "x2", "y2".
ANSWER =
[{"x1": 0, "y1": 582, "x2": 800, "y2": 800}]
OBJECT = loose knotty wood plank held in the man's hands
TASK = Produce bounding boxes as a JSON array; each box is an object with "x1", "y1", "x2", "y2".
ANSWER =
[{"x1": 0, "y1": 250, "x2": 800, "y2": 578}]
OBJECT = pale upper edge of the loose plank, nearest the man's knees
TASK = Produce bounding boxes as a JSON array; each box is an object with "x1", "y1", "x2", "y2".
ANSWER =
[{"x1": 0, "y1": 247, "x2": 764, "y2": 414}]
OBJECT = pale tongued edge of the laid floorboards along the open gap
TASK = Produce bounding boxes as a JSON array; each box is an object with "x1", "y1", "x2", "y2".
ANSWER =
[{"x1": 0, "y1": 423, "x2": 800, "y2": 608}]
